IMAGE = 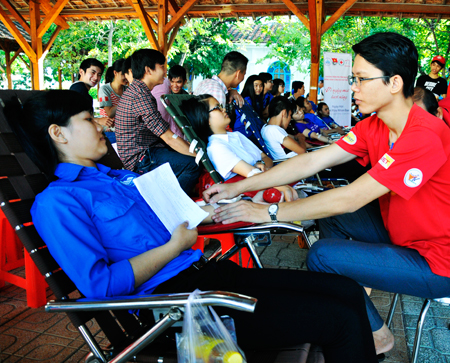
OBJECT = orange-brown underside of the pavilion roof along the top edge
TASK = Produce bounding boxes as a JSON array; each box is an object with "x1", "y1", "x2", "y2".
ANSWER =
[{"x1": 3, "y1": 0, "x2": 450, "y2": 21}]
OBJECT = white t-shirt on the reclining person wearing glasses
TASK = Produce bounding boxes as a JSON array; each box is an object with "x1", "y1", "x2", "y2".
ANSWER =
[{"x1": 207, "y1": 132, "x2": 262, "y2": 180}]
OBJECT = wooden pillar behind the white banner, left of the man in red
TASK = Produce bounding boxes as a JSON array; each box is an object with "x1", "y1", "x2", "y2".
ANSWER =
[{"x1": 308, "y1": 0, "x2": 323, "y2": 103}]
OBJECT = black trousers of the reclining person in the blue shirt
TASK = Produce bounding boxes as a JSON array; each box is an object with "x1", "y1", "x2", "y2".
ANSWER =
[{"x1": 154, "y1": 261, "x2": 378, "y2": 363}]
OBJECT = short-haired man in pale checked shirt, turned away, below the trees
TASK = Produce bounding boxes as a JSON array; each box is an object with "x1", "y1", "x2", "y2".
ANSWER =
[{"x1": 194, "y1": 52, "x2": 248, "y2": 106}]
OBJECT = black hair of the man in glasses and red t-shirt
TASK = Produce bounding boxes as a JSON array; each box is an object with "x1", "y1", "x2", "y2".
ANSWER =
[{"x1": 352, "y1": 32, "x2": 419, "y2": 98}]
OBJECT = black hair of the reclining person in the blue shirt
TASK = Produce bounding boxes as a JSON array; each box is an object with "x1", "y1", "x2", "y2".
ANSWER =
[{"x1": 4, "y1": 90, "x2": 93, "y2": 176}]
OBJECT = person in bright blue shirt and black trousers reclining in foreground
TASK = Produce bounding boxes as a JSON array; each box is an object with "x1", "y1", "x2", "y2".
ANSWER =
[{"x1": 4, "y1": 89, "x2": 377, "y2": 363}]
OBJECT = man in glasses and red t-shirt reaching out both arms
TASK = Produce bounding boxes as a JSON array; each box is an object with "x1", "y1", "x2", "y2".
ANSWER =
[{"x1": 204, "y1": 33, "x2": 450, "y2": 353}]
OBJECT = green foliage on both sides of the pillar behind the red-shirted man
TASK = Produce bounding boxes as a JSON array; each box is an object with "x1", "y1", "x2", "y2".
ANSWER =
[{"x1": 265, "y1": 16, "x2": 450, "y2": 78}]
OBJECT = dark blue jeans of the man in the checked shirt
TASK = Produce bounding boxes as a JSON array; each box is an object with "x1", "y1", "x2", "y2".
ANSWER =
[{"x1": 134, "y1": 147, "x2": 200, "y2": 195}]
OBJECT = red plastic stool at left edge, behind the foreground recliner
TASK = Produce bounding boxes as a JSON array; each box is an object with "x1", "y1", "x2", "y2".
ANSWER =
[{"x1": 0, "y1": 210, "x2": 47, "y2": 308}]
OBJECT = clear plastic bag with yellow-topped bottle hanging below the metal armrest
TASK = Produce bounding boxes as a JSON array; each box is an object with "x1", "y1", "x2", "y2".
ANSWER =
[{"x1": 177, "y1": 290, "x2": 246, "y2": 363}]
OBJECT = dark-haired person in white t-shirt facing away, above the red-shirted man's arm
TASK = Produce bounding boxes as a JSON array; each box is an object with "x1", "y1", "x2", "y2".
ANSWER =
[{"x1": 261, "y1": 96, "x2": 306, "y2": 160}]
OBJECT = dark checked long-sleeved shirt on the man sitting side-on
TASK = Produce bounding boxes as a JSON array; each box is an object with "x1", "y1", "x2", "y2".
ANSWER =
[{"x1": 115, "y1": 79, "x2": 169, "y2": 171}]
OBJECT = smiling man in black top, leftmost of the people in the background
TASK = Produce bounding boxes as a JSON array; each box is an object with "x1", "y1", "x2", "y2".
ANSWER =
[{"x1": 69, "y1": 58, "x2": 114, "y2": 127}]
